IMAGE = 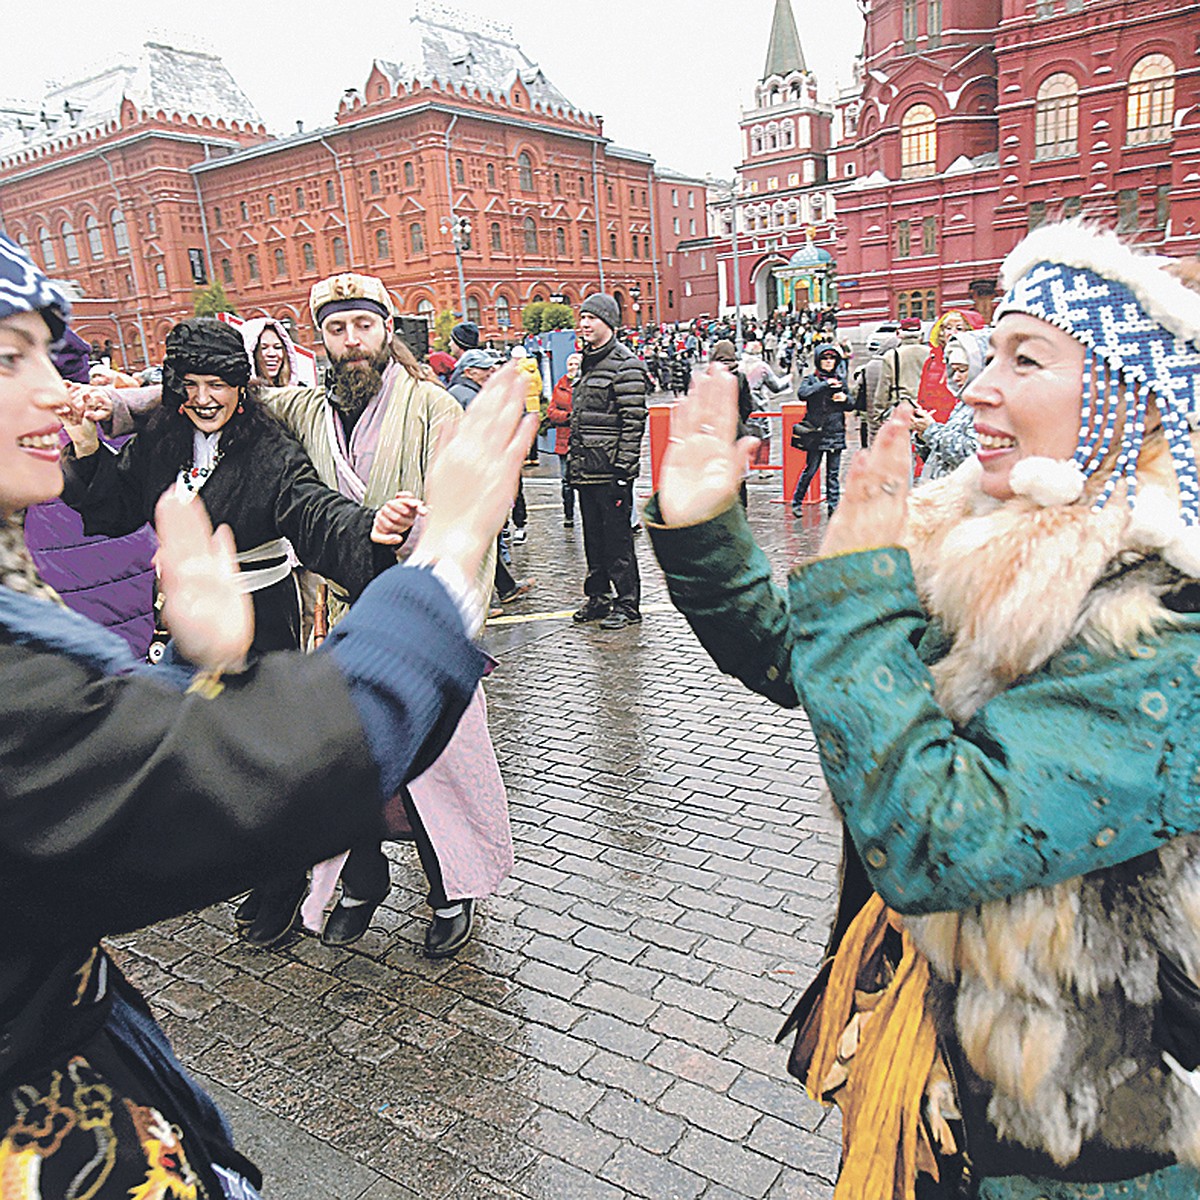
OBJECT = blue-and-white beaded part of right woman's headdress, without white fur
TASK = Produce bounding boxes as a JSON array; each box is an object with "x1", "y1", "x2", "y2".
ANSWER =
[{"x1": 997, "y1": 262, "x2": 1200, "y2": 526}]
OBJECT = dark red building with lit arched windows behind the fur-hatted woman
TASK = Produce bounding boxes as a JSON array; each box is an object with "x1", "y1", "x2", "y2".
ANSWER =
[{"x1": 836, "y1": 0, "x2": 1200, "y2": 324}]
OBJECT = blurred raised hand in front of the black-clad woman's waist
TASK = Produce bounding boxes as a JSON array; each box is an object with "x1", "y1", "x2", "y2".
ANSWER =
[{"x1": 155, "y1": 487, "x2": 254, "y2": 673}]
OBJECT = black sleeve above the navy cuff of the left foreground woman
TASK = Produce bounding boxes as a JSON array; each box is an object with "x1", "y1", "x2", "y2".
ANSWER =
[{"x1": 0, "y1": 641, "x2": 381, "y2": 946}]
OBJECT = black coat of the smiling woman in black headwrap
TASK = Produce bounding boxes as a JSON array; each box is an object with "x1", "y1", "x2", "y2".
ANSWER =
[{"x1": 62, "y1": 413, "x2": 396, "y2": 652}]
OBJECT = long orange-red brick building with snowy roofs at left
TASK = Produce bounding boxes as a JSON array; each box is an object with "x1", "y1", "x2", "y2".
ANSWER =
[{"x1": 0, "y1": 10, "x2": 660, "y2": 365}]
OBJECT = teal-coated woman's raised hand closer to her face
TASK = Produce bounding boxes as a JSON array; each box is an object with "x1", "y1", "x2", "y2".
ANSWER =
[{"x1": 821, "y1": 403, "x2": 912, "y2": 558}]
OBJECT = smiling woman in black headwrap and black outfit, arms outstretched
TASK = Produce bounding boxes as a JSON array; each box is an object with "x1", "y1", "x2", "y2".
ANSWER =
[{"x1": 62, "y1": 318, "x2": 415, "y2": 946}]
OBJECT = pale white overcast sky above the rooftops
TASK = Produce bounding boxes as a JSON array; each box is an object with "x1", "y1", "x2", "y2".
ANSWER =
[{"x1": 0, "y1": 0, "x2": 863, "y2": 178}]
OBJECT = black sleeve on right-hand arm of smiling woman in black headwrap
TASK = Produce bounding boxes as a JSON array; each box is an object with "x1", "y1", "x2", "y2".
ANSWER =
[{"x1": 263, "y1": 428, "x2": 396, "y2": 599}]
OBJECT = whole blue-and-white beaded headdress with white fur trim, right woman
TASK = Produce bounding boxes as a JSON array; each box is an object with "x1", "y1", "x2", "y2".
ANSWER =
[{"x1": 995, "y1": 222, "x2": 1200, "y2": 526}]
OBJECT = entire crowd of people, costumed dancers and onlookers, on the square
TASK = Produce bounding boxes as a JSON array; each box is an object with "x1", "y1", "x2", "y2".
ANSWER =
[{"x1": 7, "y1": 216, "x2": 1200, "y2": 1200}]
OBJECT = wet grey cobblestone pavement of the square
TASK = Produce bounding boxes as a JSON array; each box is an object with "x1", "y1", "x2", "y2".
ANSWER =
[{"x1": 114, "y1": 468, "x2": 839, "y2": 1200}]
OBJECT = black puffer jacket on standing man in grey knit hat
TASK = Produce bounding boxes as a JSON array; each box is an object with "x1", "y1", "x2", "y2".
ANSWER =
[{"x1": 566, "y1": 337, "x2": 649, "y2": 486}]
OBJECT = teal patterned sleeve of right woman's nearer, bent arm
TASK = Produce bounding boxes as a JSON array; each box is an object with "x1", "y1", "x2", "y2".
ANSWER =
[{"x1": 790, "y1": 548, "x2": 1200, "y2": 912}]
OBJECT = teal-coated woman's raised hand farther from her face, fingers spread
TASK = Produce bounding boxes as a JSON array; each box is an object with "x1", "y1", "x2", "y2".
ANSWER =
[{"x1": 659, "y1": 366, "x2": 758, "y2": 524}]
